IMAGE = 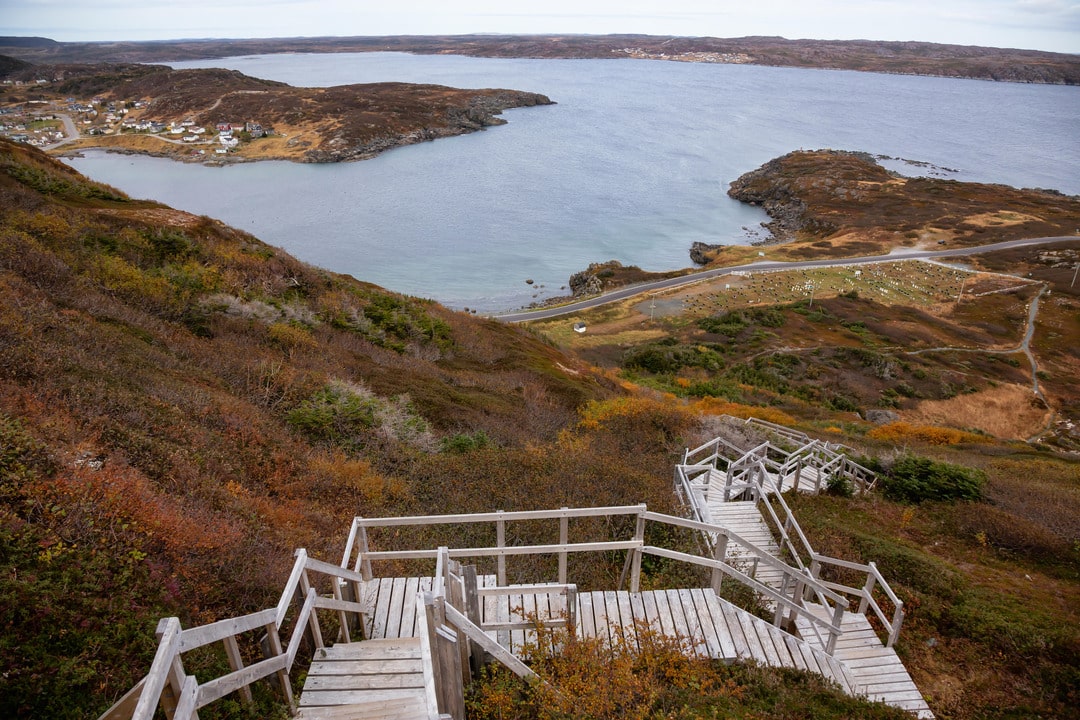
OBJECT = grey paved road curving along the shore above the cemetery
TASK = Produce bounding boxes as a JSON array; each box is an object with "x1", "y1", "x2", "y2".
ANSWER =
[{"x1": 492, "y1": 235, "x2": 1080, "y2": 323}]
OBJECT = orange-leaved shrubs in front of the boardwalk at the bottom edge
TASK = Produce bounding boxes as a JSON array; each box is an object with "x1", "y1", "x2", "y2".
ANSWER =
[{"x1": 465, "y1": 622, "x2": 907, "y2": 720}]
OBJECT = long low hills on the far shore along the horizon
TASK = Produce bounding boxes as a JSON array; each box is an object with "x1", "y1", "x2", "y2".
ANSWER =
[{"x1": 6, "y1": 35, "x2": 1080, "y2": 85}]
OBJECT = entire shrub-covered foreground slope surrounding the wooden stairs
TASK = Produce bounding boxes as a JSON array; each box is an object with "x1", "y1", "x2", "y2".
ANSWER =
[{"x1": 0, "y1": 140, "x2": 1080, "y2": 720}]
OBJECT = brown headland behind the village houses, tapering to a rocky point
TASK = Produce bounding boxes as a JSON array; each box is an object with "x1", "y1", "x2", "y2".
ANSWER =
[{"x1": 0, "y1": 64, "x2": 551, "y2": 162}]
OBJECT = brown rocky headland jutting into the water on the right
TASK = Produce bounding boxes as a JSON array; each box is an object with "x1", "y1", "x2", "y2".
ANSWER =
[{"x1": 728, "y1": 150, "x2": 1080, "y2": 258}]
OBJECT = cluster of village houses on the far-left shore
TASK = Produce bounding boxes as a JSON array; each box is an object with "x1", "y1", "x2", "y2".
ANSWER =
[{"x1": 0, "y1": 76, "x2": 269, "y2": 155}]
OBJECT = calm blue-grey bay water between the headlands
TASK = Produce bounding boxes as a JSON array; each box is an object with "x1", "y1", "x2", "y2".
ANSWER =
[{"x1": 70, "y1": 53, "x2": 1080, "y2": 312}]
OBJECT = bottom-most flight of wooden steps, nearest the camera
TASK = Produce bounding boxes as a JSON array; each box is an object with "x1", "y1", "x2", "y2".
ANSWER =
[{"x1": 298, "y1": 637, "x2": 429, "y2": 720}]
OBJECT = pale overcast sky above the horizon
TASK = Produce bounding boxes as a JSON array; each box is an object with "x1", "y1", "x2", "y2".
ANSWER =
[{"x1": 0, "y1": 0, "x2": 1080, "y2": 53}]
